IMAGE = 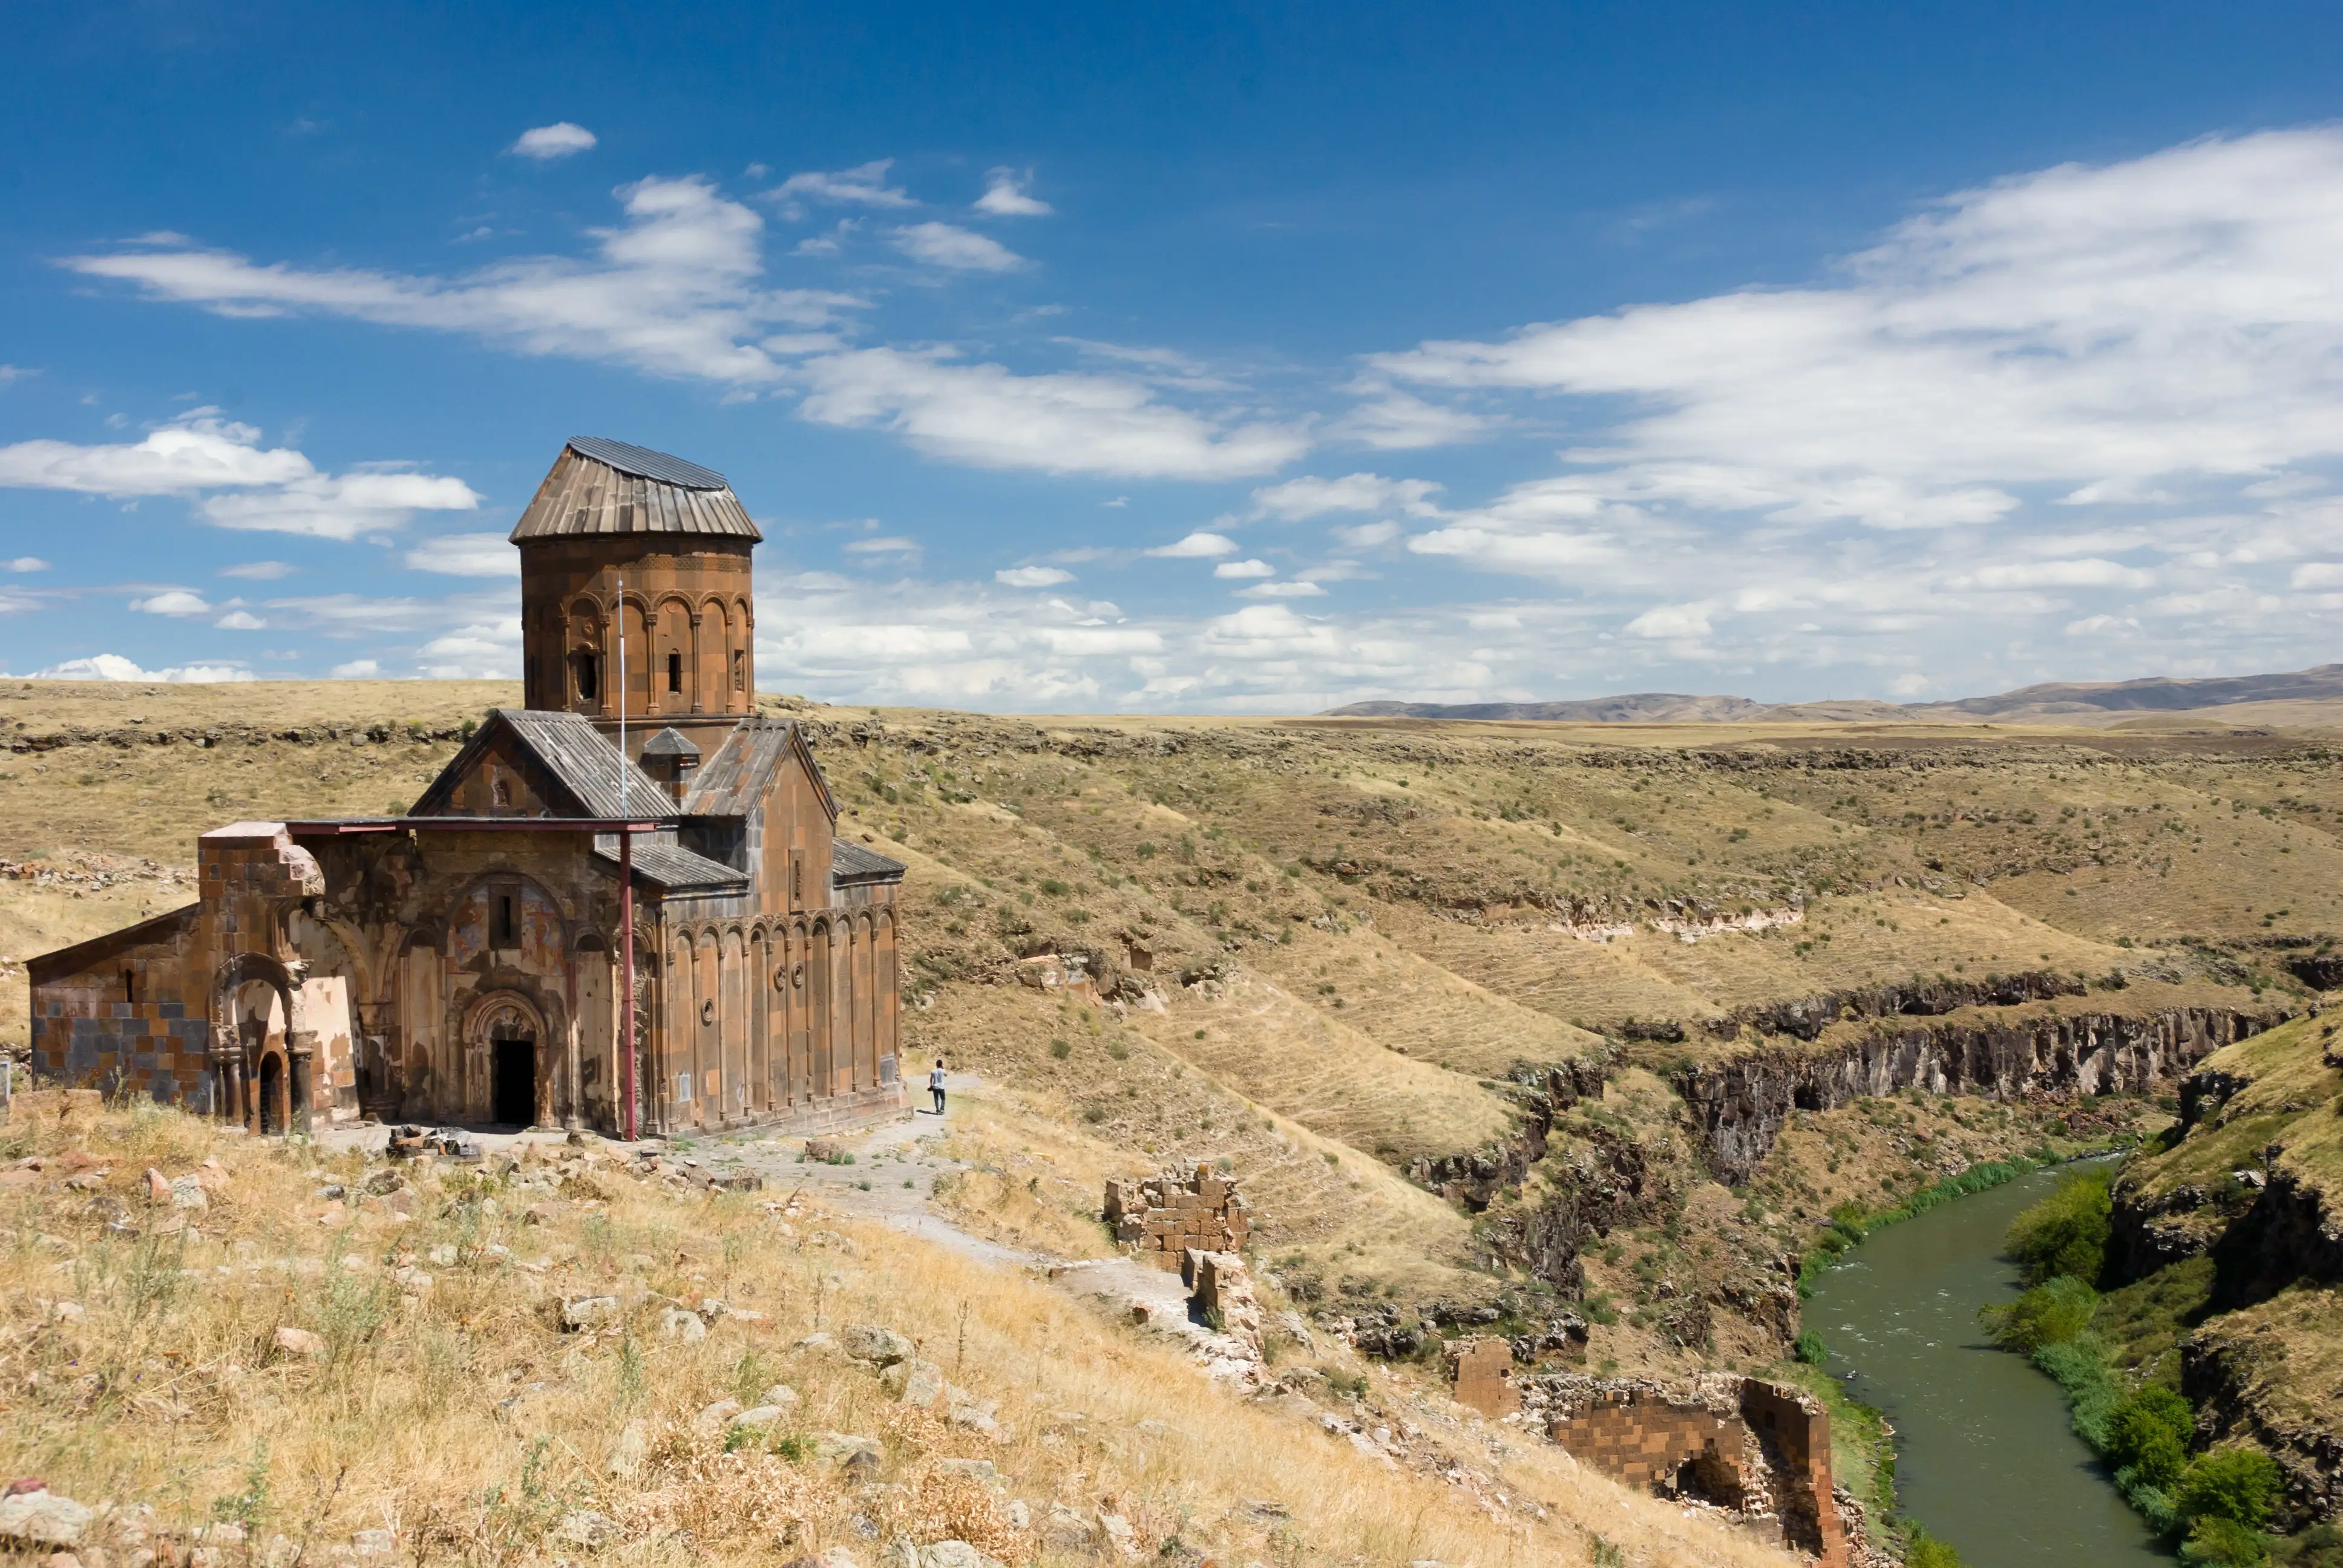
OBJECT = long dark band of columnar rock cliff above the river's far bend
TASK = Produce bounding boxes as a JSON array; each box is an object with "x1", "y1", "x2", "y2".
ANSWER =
[{"x1": 1675, "y1": 1008, "x2": 2282, "y2": 1186}]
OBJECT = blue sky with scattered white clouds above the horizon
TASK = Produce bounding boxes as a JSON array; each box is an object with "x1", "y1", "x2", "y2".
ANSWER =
[{"x1": 0, "y1": 2, "x2": 2343, "y2": 713}]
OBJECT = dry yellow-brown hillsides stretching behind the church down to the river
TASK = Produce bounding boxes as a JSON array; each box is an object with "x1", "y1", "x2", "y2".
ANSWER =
[{"x1": 0, "y1": 682, "x2": 2343, "y2": 1563}]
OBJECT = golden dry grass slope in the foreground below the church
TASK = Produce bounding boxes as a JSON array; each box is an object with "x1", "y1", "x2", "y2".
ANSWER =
[{"x1": 0, "y1": 1104, "x2": 1790, "y2": 1568}]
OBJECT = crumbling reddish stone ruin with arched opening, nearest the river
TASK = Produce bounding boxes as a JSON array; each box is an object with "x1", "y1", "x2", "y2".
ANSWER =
[{"x1": 1523, "y1": 1373, "x2": 1851, "y2": 1568}]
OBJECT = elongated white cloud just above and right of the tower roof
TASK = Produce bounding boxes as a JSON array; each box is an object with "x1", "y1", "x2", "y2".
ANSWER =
[{"x1": 801, "y1": 349, "x2": 1308, "y2": 478}]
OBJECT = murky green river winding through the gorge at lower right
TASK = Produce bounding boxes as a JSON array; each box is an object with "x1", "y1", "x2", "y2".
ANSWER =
[{"x1": 1806, "y1": 1169, "x2": 2172, "y2": 1568}]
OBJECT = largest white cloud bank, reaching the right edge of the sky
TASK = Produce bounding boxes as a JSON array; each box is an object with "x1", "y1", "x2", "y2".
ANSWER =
[{"x1": 1373, "y1": 129, "x2": 2343, "y2": 528}]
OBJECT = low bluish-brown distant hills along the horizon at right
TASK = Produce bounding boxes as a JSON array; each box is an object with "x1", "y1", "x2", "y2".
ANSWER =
[{"x1": 1322, "y1": 663, "x2": 2343, "y2": 724}]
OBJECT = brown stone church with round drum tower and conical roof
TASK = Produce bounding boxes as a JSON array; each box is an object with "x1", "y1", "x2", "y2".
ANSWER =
[{"x1": 30, "y1": 436, "x2": 906, "y2": 1137}]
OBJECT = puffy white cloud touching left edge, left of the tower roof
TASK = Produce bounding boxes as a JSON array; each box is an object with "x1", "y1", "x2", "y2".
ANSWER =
[{"x1": 0, "y1": 408, "x2": 480, "y2": 539}]
